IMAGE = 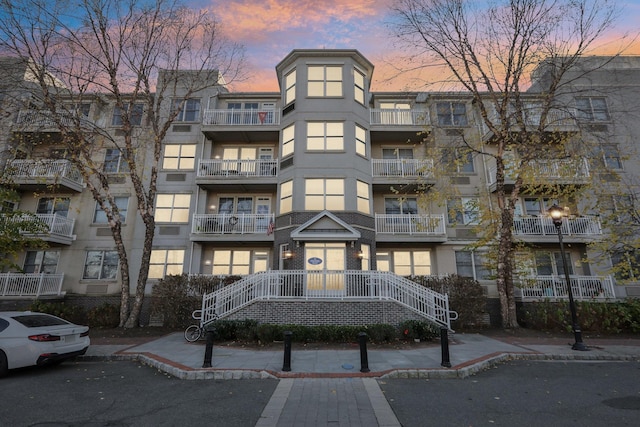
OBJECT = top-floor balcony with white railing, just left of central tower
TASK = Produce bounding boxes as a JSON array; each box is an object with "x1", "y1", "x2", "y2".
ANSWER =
[{"x1": 202, "y1": 108, "x2": 280, "y2": 143}]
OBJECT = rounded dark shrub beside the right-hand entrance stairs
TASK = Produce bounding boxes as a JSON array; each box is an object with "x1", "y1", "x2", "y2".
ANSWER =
[{"x1": 409, "y1": 274, "x2": 487, "y2": 328}]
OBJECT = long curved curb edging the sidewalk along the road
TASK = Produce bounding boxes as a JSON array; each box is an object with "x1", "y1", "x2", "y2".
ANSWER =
[{"x1": 76, "y1": 353, "x2": 640, "y2": 380}]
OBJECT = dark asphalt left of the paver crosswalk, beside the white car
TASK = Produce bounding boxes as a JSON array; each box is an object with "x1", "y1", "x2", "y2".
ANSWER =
[{"x1": 0, "y1": 362, "x2": 278, "y2": 427}]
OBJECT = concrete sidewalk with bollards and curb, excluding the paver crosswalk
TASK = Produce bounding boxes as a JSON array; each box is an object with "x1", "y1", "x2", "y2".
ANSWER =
[{"x1": 83, "y1": 333, "x2": 640, "y2": 379}]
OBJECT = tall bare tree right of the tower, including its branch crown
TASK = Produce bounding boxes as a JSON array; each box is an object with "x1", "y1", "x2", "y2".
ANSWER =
[{"x1": 391, "y1": 0, "x2": 617, "y2": 328}]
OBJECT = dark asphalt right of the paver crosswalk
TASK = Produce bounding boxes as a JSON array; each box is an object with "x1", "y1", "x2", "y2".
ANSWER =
[{"x1": 378, "y1": 361, "x2": 640, "y2": 427}]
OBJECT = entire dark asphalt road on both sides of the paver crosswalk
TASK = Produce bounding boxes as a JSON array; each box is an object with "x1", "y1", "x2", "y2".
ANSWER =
[{"x1": 0, "y1": 361, "x2": 640, "y2": 427}]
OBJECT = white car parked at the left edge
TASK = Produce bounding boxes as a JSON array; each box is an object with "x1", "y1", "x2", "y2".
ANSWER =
[{"x1": 0, "y1": 311, "x2": 90, "y2": 378}]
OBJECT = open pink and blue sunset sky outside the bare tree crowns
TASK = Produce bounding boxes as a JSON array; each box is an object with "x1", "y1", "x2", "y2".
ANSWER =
[{"x1": 190, "y1": 0, "x2": 640, "y2": 92}]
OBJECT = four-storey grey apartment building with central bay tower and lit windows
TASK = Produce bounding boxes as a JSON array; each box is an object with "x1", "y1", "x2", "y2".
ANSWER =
[{"x1": 0, "y1": 49, "x2": 640, "y2": 324}]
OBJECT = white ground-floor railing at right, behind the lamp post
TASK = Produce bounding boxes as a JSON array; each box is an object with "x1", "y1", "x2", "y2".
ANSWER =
[{"x1": 516, "y1": 275, "x2": 615, "y2": 301}]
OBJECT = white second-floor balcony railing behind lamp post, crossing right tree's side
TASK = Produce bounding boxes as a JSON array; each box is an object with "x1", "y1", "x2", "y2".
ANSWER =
[{"x1": 513, "y1": 215, "x2": 602, "y2": 236}]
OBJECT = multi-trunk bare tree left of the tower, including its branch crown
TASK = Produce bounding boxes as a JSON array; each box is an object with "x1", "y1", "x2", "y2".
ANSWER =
[{"x1": 0, "y1": 0, "x2": 244, "y2": 327}]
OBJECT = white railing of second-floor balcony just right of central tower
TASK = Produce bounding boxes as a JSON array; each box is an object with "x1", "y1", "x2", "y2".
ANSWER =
[{"x1": 376, "y1": 214, "x2": 446, "y2": 236}]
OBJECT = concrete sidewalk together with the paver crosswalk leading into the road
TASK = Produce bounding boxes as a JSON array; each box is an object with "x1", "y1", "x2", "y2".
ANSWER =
[{"x1": 82, "y1": 333, "x2": 640, "y2": 427}]
